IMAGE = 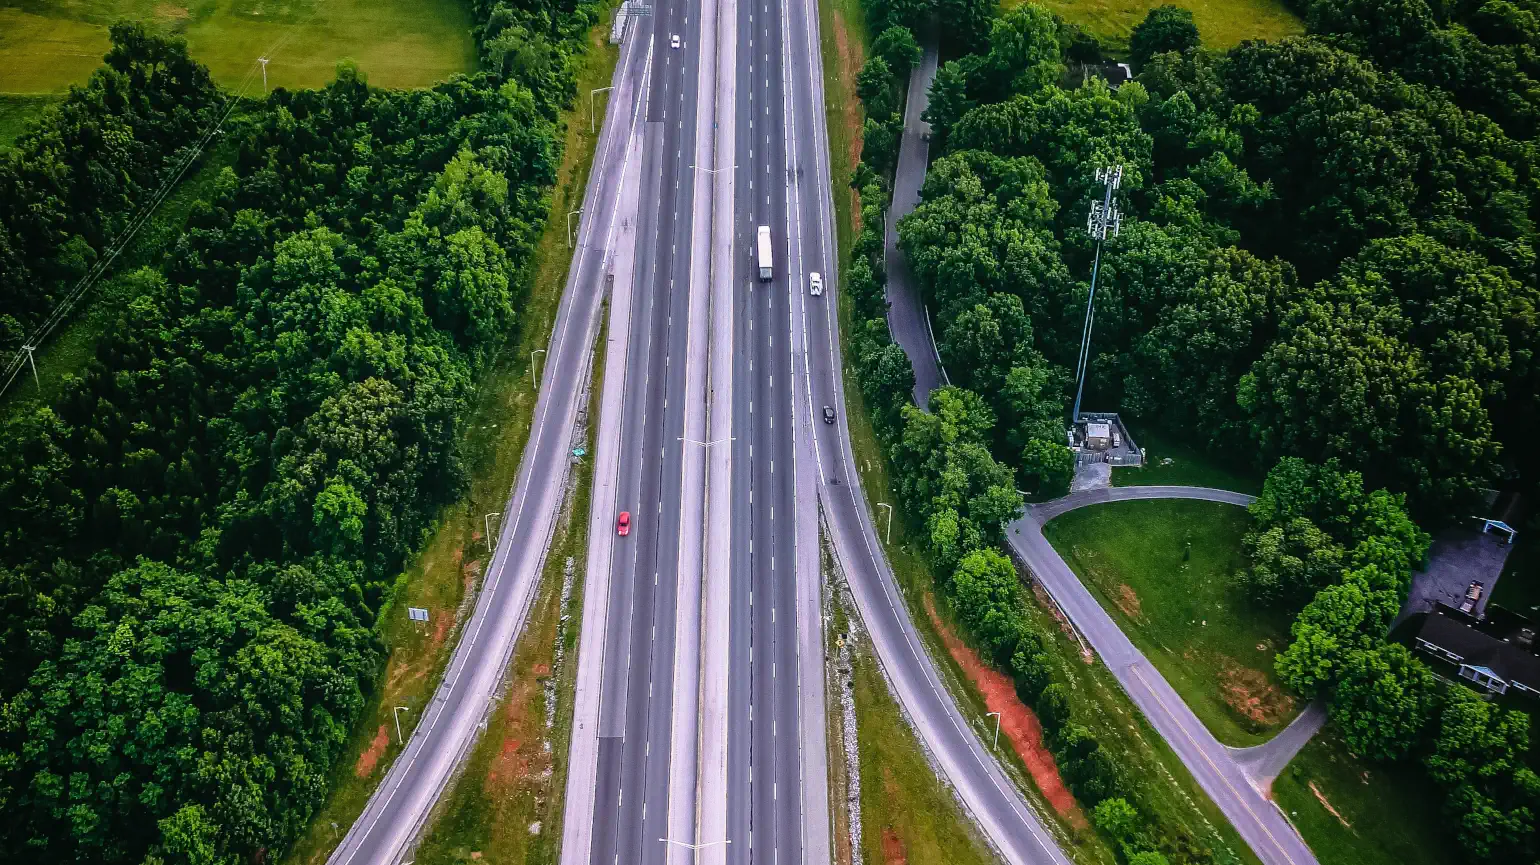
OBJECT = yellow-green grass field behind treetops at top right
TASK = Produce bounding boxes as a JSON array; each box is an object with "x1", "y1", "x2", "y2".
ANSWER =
[{"x1": 1004, "y1": 0, "x2": 1304, "y2": 49}]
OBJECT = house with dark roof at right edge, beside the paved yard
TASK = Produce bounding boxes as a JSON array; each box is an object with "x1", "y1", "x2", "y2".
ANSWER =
[{"x1": 1414, "y1": 603, "x2": 1540, "y2": 694}]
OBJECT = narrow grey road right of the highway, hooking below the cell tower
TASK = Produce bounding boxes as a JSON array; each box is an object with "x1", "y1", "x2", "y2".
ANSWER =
[{"x1": 1006, "y1": 486, "x2": 1315, "y2": 865}]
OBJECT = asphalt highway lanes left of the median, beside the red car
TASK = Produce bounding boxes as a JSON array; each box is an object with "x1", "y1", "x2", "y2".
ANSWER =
[{"x1": 585, "y1": 0, "x2": 704, "y2": 865}]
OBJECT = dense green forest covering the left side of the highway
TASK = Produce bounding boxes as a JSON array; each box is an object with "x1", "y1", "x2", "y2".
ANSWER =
[{"x1": 0, "y1": 0, "x2": 598, "y2": 865}]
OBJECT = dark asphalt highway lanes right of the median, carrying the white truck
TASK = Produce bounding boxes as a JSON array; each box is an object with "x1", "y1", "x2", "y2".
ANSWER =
[{"x1": 724, "y1": 0, "x2": 827, "y2": 865}]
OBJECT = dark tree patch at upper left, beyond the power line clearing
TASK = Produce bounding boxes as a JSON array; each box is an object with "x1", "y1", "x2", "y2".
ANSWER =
[{"x1": 0, "y1": 23, "x2": 223, "y2": 352}]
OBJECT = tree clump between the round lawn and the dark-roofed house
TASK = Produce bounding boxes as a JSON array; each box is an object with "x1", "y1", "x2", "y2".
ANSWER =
[{"x1": 1246, "y1": 459, "x2": 1540, "y2": 862}]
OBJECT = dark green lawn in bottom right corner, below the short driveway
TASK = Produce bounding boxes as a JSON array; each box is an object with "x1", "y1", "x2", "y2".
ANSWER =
[{"x1": 1272, "y1": 726, "x2": 1463, "y2": 865}]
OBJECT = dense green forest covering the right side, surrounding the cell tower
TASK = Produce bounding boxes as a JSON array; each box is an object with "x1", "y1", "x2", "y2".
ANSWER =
[{"x1": 845, "y1": 0, "x2": 1540, "y2": 862}]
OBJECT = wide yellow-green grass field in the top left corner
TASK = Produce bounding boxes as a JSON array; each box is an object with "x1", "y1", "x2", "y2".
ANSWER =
[{"x1": 0, "y1": 0, "x2": 476, "y2": 94}]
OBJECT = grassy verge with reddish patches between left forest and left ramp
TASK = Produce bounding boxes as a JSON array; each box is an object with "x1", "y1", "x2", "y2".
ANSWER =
[{"x1": 285, "y1": 23, "x2": 619, "y2": 865}]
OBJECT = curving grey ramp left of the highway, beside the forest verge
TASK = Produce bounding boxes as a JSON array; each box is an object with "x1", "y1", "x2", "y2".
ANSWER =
[{"x1": 330, "y1": 18, "x2": 647, "y2": 865}]
